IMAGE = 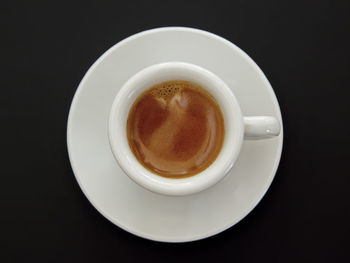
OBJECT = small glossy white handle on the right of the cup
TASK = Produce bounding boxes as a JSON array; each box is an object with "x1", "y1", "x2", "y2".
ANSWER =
[{"x1": 243, "y1": 116, "x2": 281, "y2": 140}]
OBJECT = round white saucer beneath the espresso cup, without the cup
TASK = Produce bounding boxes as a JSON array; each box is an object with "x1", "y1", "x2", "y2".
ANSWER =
[{"x1": 67, "y1": 27, "x2": 283, "y2": 242}]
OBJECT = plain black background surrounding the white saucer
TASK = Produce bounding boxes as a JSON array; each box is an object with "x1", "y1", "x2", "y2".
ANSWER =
[{"x1": 0, "y1": 0, "x2": 350, "y2": 262}]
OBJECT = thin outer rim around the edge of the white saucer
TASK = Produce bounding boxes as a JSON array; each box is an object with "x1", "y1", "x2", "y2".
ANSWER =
[{"x1": 66, "y1": 27, "x2": 284, "y2": 243}]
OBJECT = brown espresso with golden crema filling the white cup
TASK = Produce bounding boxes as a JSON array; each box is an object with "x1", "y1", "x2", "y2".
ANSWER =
[{"x1": 127, "y1": 80, "x2": 225, "y2": 178}]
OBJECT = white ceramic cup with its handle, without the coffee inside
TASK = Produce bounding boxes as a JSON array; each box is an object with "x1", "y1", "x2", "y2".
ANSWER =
[{"x1": 108, "y1": 62, "x2": 280, "y2": 196}]
